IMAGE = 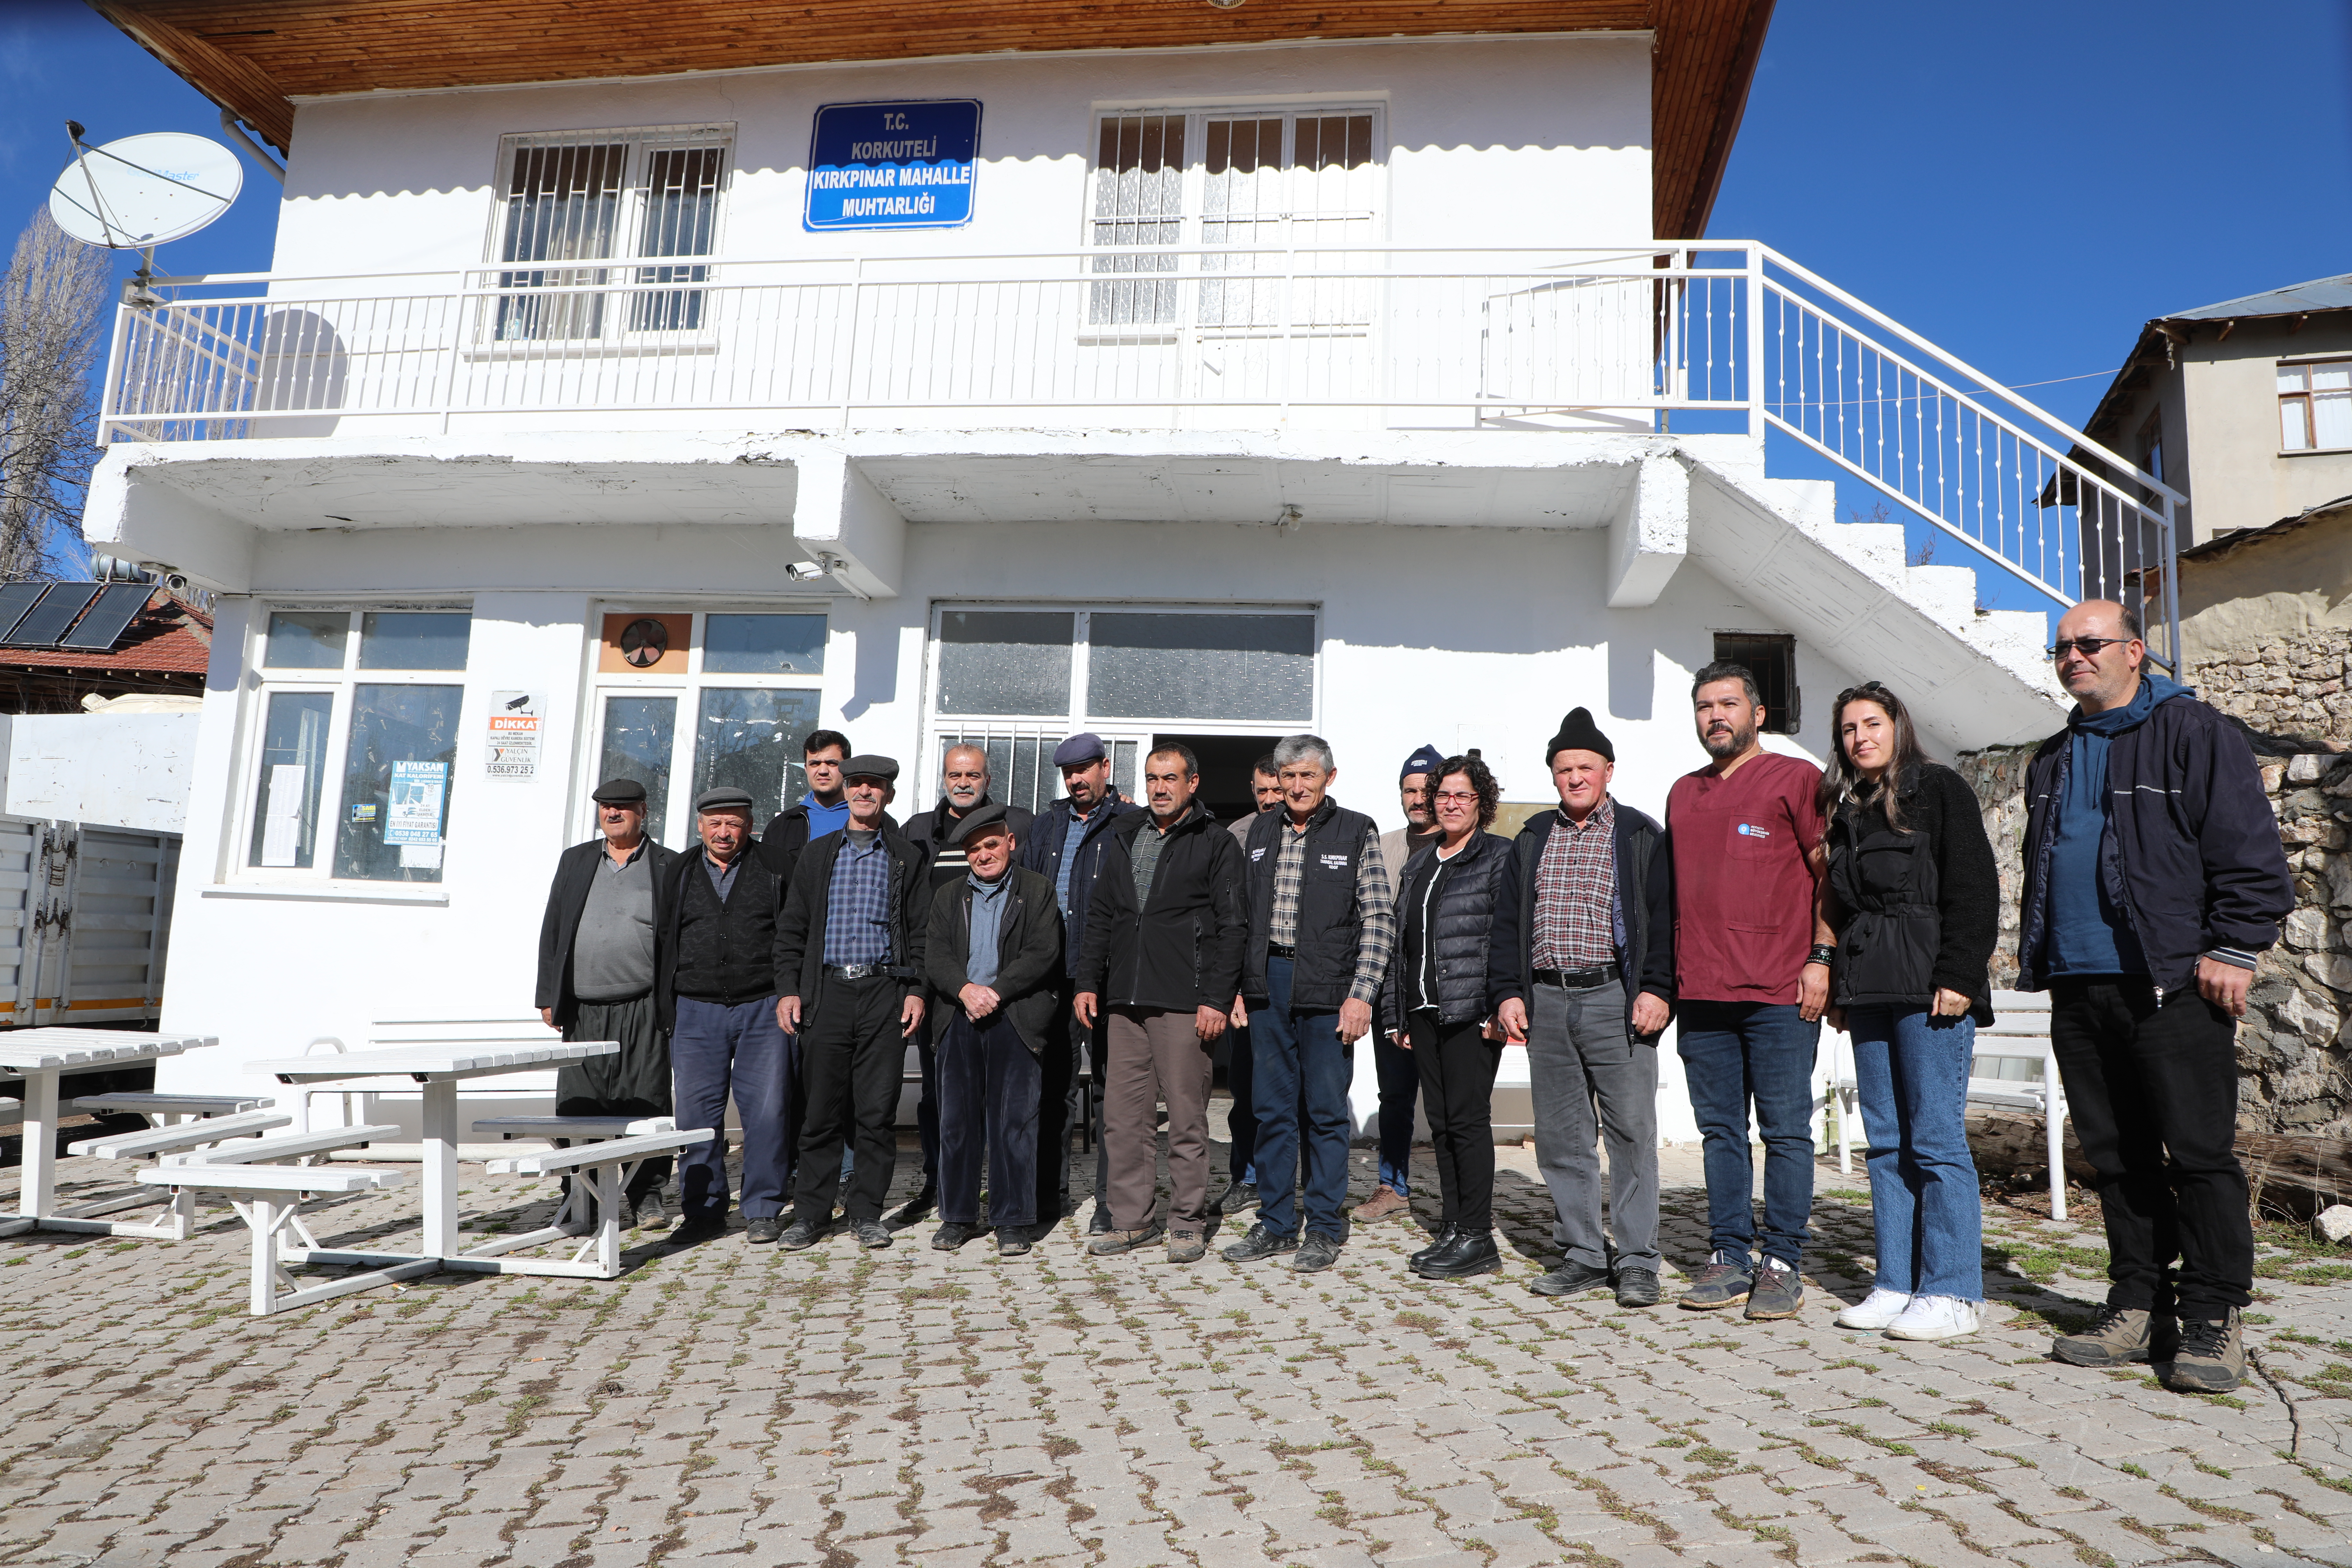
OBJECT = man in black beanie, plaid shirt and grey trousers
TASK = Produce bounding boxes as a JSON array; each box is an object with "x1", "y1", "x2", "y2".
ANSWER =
[{"x1": 1486, "y1": 708, "x2": 1675, "y2": 1307}]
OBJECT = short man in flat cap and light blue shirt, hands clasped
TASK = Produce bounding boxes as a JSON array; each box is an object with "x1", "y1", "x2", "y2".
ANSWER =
[{"x1": 924, "y1": 804, "x2": 1061, "y2": 1258}]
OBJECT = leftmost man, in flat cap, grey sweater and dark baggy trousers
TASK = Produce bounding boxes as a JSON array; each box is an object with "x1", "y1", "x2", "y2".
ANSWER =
[{"x1": 536, "y1": 778, "x2": 677, "y2": 1234}]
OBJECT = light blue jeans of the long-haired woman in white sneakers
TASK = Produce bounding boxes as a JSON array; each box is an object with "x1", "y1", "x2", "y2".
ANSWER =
[{"x1": 1846, "y1": 1006, "x2": 1985, "y2": 1302}]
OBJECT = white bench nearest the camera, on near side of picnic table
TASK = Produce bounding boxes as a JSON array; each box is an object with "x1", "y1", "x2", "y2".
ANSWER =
[{"x1": 134, "y1": 1126, "x2": 414, "y2": 1316}]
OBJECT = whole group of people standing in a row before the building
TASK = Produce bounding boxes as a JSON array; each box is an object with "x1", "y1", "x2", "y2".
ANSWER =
[{"x1": 539, "y1": 602, "x2": 2293, "y2": 1392}]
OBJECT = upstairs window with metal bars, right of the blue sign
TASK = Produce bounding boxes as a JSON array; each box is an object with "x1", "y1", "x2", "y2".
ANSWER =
[{"x1": 1089, "y1": 108, "x2": 1385, "y2": 327}]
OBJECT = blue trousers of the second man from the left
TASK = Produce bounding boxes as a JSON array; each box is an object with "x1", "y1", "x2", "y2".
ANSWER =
[{"x1": 670, "y1": 997, "x2": 797, "y2": 1220}]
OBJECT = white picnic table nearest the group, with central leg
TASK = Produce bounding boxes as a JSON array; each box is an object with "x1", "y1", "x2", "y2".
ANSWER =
[{"x1": 245, "y1": 1037, "x2": 621, "y2": 1274}]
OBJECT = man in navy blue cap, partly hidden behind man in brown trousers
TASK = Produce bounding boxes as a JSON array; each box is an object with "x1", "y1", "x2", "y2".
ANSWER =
[{"x1": 1021, "y1": 734, "x2": 1136, "y2": 1237}]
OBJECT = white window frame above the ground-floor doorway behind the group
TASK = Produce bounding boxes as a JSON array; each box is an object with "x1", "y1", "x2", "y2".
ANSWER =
[{"x1": 917, "y1": 600, "x2": 1324, "y2": 818}]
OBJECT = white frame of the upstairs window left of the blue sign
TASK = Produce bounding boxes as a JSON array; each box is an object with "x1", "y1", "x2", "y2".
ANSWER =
[{"x1": 468, "y1": 120, "x2": 736, "y2": 357}]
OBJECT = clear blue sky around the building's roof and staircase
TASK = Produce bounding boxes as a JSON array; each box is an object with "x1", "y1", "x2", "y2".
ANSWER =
[{"x1": 0, "y1": 0, "x2": 2352, "y2": 602}]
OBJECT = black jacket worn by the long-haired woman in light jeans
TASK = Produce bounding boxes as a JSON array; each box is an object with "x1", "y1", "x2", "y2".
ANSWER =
[{"x1": 1827, "y1": 762, "x2": 2002, "y2": 1027}]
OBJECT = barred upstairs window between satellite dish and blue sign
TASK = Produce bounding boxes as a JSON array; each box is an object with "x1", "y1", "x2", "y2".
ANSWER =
[{"x1": 491, "y1": 125, "x2": 734, "y2": 343}]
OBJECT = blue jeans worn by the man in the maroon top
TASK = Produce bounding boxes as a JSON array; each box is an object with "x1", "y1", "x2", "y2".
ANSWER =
[{"x1": 1677, "y1": 1001, "x2": 1820, "y2": 1269}]
